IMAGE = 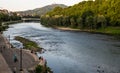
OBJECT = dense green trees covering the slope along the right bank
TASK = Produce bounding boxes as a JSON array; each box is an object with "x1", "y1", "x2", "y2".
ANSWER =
[{"x1": 41, "y1": 0, "x2": 120, "y2": 34}]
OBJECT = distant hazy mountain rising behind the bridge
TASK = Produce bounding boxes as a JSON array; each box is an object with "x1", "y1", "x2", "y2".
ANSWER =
[{"x1": 17, "y1": 4, "x2": 67, "y2": 15}]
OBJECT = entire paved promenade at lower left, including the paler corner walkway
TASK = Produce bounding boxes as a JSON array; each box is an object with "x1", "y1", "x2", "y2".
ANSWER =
[{"x1": 0, "y1": 34, "x2": 39, "y2": 73}]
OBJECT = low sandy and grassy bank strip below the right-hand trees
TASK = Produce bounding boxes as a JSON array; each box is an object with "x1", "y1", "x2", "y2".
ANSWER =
[{"x1": 54, "y1": 27, "x2": 120, "y2": 39}]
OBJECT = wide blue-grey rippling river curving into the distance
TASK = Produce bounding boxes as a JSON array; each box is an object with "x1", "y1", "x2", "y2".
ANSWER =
[{"x1": 3, "y1": 22, "x2": 120, "y2": 73}]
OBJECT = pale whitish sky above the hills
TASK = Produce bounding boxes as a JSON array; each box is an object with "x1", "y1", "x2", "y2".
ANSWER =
[{"x1": 0, "y1": 0, "x2": 83, "y2": 11}]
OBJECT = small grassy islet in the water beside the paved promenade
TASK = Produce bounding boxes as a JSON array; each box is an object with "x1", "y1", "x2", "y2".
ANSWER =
[{"x1": 15, "y1": 36, "x2": 41, "y2": 51}]
